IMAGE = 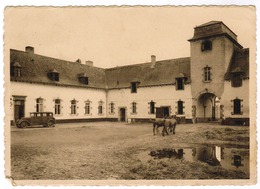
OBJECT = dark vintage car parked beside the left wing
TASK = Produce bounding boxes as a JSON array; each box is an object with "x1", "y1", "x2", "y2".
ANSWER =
[{"x1": 16, "y1": 112, "x2": 56, "y2": 128}]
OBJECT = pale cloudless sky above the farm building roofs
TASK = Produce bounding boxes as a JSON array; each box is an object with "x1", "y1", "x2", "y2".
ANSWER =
[{"x1": 4, "y1": 7, "x2": 255, "y2": 68}]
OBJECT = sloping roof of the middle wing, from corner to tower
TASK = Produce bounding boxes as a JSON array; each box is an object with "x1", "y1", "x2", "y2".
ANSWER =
[{"x1": 106, "y1": 57, "x2": 190, "y2": 89}]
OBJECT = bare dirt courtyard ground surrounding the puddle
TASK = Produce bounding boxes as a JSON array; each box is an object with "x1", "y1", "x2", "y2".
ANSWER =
[{"x1": 11, "y1": 122, "x2": 249, "y2": 180}]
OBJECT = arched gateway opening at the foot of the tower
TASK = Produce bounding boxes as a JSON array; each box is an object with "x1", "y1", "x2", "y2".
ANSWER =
[{"x1": 196, "y1": 92, "x2": 219, "y2": 122}]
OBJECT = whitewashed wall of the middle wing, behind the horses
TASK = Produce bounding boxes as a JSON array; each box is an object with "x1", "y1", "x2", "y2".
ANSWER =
[{"x1": 107, "y1": 85, "x2": 192, "y2": 119}]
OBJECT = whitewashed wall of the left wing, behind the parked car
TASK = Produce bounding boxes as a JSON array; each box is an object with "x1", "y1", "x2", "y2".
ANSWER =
[{"x1": 10, "y1": 82, "x2": 106, "y2": 120}]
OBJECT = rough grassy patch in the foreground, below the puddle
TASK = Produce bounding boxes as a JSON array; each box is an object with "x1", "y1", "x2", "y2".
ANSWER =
[{"x1": 122, "y1": 159, "x2": 248, "y2": 180}]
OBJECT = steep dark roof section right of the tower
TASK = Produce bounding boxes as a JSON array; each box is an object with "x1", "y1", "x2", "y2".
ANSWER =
[{"x1": 225, "y1": 48, "x2": 249, "y2": 80}]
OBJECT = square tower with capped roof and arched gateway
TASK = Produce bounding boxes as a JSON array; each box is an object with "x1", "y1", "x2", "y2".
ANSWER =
[{"x1": 188, "y1": 21, "x2": 243, "y2": 121}]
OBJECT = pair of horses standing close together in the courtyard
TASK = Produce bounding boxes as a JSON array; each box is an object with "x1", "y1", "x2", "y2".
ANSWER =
[{"x1": 153, "y1": 116, "x2": 177, "y2": 136}]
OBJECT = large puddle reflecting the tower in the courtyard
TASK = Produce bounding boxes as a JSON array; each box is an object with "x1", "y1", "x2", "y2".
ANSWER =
[{"x1": 138, "y1": 146, "x2": 249, "y2": 175}]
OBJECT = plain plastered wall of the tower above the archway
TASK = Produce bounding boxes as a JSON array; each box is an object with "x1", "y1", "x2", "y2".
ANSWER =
[{"x1": 190, "y1": 36, "x2": 233, "y2": 97}]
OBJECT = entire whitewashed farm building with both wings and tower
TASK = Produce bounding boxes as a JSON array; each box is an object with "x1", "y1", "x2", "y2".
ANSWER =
[{"x1": 10, "y1": 21, "x2": 249, "y2": 125}]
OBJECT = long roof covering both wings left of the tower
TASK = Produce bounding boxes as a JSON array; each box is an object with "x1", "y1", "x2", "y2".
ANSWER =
[{"x1": 10, "y1": 49, "x2": 190, "y2": 89}]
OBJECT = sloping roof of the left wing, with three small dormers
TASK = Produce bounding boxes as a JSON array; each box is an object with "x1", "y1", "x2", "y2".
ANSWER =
[{"x1": 10, "y1": 49, "x2": 105, "y2": 89}]
